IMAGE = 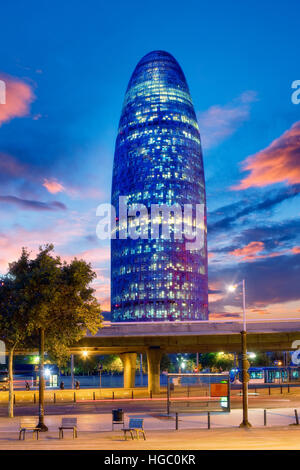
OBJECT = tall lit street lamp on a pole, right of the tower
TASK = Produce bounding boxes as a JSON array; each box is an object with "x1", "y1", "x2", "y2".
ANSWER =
[{"x1": 227, "y1": 279, "x2": 251, "y2": 428}]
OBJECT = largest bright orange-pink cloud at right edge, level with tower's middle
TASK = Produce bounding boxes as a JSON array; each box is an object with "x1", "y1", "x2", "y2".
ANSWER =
[{"x1": 232, "y1": 121, "x2": 300, "y2": 190}]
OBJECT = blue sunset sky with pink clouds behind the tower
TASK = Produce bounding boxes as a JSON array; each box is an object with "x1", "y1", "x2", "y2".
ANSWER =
[{"x1": 0, "y1": 0, "x2": 300, "y2": 319}]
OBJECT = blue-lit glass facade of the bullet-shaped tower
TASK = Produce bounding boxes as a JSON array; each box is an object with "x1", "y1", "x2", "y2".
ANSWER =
[{"x1": 111, "y1": 51, "x2": 208, "y2": 321}]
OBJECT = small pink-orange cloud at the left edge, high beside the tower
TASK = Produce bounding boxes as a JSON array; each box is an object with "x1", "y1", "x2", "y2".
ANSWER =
[{"x1": 0, "y1": 74, "x2": 35, "y2": 126}]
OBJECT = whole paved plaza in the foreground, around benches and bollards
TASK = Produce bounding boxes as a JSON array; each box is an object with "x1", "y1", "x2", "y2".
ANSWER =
[{"x1": 0, "y1": 408, "x2": 300, "y2": 450}]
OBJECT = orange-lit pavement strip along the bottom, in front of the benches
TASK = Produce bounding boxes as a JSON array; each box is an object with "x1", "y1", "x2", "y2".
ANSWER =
[{"x1": 0, "y1": 426, "x2": 300, "y2": 455}]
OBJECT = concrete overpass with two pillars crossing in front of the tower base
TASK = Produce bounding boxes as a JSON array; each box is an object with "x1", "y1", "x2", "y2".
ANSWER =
[{"x1": 71, "y1": 319, "x2": 300, "y2": 393}]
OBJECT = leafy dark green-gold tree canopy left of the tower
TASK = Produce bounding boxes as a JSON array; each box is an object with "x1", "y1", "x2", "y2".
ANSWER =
[{"x1": 0, "y1": 245, "x2": 102, "y2": 364}]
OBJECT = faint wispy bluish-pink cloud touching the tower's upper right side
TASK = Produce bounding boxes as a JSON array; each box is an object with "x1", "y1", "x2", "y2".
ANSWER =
[{"x1": 197, "y1": 90, "x2": 257, "y2": 149}]
